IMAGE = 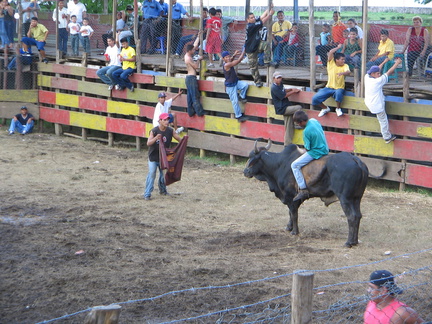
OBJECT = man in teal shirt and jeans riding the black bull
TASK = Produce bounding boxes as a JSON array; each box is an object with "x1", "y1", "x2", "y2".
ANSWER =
[{"x1": 291, "y1": 110, "x2": 329, "y2": 201}]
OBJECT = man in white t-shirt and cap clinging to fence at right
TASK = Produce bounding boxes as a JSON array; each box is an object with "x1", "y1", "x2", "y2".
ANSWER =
[{"x1": 364, "y1": 57, "x2": 402, "y2": 144}]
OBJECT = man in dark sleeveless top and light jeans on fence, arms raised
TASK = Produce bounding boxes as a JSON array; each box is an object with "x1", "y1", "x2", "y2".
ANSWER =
[{"x1": 222, "y1": 50, "x2": 249, "y2": 123}]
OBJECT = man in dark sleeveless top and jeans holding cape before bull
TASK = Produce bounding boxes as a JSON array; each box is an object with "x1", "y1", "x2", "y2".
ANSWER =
[{"x1": 144, "y1": 113, "x2": 181, "y2": 200}]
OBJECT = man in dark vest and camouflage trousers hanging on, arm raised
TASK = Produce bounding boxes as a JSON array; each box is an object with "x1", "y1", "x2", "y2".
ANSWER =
[{"x1": 245, "y1": 3, "x2": 274, "y2": 87}]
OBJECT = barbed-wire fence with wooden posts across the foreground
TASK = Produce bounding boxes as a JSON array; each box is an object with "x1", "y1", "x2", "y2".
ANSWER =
[{"x1": 33, "y1": 248, "x2": 432, "y2": 324}]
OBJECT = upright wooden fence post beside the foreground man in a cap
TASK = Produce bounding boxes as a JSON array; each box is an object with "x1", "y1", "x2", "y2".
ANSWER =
[{"x1": 291, "y1": 271, "x2": 314, "y2": 324}]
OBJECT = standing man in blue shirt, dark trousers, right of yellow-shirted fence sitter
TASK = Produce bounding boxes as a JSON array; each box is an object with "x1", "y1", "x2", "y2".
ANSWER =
[{"x1": 140, "y1": 0, "x2": 163, "y2": 54}]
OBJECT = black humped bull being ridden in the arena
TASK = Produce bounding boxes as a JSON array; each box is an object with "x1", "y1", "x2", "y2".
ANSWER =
[{"x1": 243, "y1": 142, "x2": 369, "y2": 247}]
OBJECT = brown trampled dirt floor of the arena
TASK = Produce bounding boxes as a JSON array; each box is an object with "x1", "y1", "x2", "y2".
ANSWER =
[{"x1": 0, "y1": 127, "x2": 432, "y2": 323}]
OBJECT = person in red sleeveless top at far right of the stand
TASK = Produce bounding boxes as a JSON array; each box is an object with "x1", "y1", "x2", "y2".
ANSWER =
[{"x1": 401, "y1": 16, "x2": 429, "y2": 76}]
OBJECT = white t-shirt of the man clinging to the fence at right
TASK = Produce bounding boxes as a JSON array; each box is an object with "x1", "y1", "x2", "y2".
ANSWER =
[{"x1": 365, "y1": 73, "x2": 388, "y2": 114}]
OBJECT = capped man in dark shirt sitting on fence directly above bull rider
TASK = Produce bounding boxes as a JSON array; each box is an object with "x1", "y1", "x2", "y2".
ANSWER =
[{"x1": 270, "y1": 71, "x2": 302, "y2": 146}]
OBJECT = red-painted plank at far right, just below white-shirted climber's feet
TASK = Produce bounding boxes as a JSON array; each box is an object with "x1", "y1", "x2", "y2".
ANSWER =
[{"x1": 393, "y1": 140, "x2": 432, "y2": 161}]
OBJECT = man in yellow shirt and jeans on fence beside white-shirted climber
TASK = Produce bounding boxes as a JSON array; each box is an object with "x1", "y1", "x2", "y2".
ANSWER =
[{"x1": 312, "y1": 44, "x2": 351, "y2": 117}]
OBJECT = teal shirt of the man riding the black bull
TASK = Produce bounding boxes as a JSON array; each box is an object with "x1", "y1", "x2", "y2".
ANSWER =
[{"x1": 303, "y1": 118, "x2": 329, "y2": 159}]
